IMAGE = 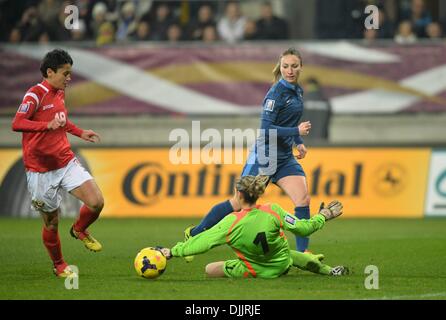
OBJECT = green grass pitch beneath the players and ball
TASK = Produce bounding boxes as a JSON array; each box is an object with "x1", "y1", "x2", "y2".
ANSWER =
[{"x1": 0, "y1": 218, "x2": 446, "y2": 300}]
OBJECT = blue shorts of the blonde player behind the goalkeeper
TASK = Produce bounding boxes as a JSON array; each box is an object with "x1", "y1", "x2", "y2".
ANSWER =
[{"x1": 241, "y1": 156, "x2": 305, "y2": 183}]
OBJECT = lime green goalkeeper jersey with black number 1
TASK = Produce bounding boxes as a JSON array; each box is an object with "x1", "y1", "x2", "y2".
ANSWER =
[{"x1": 172, "y1": 204, "x2": 325, "y2": 277}]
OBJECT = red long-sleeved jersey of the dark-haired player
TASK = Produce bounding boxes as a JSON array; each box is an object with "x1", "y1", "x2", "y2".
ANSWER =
[{"x1": 12, "y1": 80, "x2": 82, "y2": 172}]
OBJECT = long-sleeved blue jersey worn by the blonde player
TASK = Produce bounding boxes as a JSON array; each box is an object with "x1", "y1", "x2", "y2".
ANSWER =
[{"x1": 255, "y1": 79, "x2": 304, "y2": 162}]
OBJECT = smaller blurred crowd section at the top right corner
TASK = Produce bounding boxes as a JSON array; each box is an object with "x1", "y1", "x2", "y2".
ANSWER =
[{"x1": 316, "y1": 0, "x2": 446, "y2": 44}]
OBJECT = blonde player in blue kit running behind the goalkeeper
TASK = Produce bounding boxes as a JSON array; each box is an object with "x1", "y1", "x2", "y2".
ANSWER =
[{"x1": 184, "y1": 48, "x2": 311, "y2": 254}]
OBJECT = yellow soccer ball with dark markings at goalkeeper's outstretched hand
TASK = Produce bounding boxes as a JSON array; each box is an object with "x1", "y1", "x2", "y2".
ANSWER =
[{"x1": 135, "y1": 247, "x2": 167, "y2": 279}]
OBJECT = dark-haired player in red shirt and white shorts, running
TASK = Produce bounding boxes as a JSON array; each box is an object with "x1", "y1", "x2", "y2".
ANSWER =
[{"x1": 12, "y1": 49, "x2": 104, "y2": 277}]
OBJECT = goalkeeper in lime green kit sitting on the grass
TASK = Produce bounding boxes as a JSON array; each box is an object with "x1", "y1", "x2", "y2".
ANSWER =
[{"x1": 158, "y1": 176, "x2": 348, "y2": 278}]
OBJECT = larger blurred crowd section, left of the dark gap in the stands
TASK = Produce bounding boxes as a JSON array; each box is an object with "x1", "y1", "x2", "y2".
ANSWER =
[{"x1": 0, "y1": 0, "x2": 289, "y2": 45}]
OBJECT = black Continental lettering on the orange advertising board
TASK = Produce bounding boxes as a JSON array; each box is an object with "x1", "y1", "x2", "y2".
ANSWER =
[{"x1": 122, "y1": 162, "x2": 363, "y2": 206}]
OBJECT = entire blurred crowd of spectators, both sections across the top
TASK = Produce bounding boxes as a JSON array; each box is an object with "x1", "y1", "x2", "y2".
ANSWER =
[{"x1": 0, "y1": 0, "x2": 445, "y2": 46}]
